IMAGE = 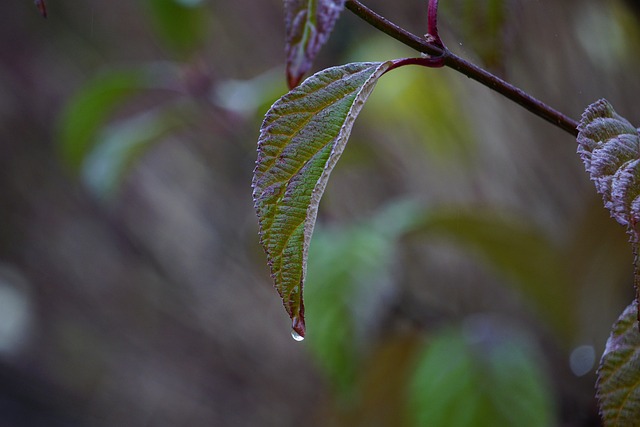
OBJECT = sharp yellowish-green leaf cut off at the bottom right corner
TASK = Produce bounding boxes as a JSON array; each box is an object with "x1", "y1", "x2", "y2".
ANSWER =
[{"x1": 597, "y1": 301, "x2": 640, "y2": 426}]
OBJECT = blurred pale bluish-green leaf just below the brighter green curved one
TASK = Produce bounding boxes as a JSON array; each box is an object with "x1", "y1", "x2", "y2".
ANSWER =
[{"x1": 82, "y1": 108, "x2": 185, "y2": 198}]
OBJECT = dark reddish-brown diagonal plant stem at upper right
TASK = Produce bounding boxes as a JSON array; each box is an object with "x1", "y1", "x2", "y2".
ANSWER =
[{"x1": 345, "y1": 0, "x2": 578, "y2": 137}]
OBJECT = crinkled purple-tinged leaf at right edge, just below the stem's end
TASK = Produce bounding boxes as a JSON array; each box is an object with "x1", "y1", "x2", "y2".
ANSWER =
[{"x1": 578, "y1": 99, "x2": 640, "y2": 229}]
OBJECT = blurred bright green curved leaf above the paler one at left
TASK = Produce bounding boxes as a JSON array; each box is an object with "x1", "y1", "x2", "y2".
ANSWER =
[{"x1": 59, "y1": 63, "x2": 178, "y2": 171}]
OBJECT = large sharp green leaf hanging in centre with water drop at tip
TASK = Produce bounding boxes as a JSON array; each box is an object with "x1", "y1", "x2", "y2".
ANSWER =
[{"x1": 252, "y1": 62, "x2": 397, "y2": 336}]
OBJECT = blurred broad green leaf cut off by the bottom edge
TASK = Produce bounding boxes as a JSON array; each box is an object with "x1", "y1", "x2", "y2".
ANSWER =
[{"x1": 407, "y1": 315, "x2": 554, "y2": 427}]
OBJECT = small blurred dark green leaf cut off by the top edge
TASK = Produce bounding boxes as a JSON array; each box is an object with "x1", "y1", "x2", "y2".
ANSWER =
[{"x1": 147, "y1": 0, "x2": 206, "y2": 55}]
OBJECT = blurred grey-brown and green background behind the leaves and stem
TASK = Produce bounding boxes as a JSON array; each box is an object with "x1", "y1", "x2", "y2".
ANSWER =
[{"x1": 0, "y1": 0, "x2": 640, "y2": 427}]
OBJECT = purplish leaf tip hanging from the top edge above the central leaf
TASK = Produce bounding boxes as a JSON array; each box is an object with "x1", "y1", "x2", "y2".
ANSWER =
[{"x1": 284, "y1": 0, "x2": 344, "y2": 89}]
